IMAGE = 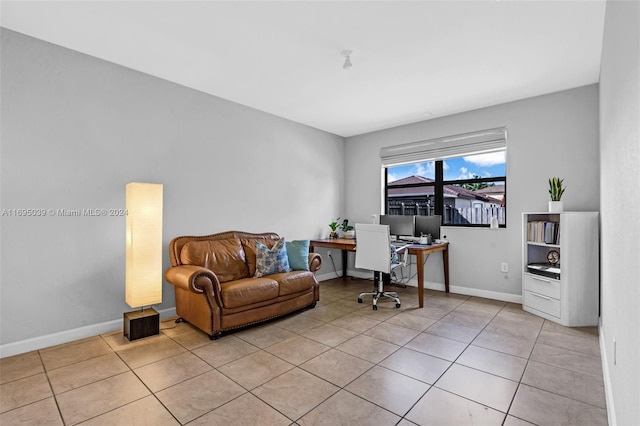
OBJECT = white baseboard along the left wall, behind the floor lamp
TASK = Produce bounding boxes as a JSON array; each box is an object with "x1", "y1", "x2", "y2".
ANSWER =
[{"x1": 0, "y1": 307, "x2": 176, "y2": 358}]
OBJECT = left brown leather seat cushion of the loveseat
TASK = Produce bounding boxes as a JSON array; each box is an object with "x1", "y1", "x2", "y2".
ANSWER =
[{"x1": 220, "y1": 278, "x2": 279, "y2": 308}]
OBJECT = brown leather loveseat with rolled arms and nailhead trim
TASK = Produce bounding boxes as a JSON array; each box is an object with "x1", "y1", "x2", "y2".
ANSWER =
[{"x1": 165, "y1": 231, "x2": 322, "y2": 339}]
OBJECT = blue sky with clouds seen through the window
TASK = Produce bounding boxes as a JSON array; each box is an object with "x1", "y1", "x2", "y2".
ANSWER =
[{"x1": 388, "y1": 151, "x2": 507, "y2": 182}]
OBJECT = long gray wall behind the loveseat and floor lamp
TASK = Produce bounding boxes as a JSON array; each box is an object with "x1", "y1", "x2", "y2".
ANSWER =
[{"x1": 0, "y1": 29, "x2": 344, "y2": 356}]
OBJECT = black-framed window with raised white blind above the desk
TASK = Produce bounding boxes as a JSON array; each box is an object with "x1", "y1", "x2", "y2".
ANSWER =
[{"x1": 381, "y1": 128, "x2": 507, "y2": 227}]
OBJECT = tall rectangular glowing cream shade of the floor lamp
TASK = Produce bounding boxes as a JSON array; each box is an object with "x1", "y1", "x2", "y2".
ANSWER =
[{"x1": 125, "y1": 182, "x2": 162, "y2": 308}]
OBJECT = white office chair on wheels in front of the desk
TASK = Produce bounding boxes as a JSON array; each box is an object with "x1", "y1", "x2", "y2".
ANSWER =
[{"x1": 356, "y1": 223, "x2": 409, "y2": 310}]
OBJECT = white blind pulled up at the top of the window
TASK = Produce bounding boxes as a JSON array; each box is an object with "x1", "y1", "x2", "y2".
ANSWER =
[{"x1": 380, "y1": 127, "x2": 507, "y2": 167}]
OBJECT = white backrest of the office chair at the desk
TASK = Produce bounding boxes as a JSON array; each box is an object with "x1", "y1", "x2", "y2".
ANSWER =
[{"x1": 356, "y1": 223, "x2": 391, "y2": 274}]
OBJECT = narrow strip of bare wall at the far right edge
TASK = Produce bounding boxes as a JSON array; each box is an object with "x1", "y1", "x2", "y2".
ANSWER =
[{"x1": 600, "y1": 1, "x2": 640, "y2": 425}]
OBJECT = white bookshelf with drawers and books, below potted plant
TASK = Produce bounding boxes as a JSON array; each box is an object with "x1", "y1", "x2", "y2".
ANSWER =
[{"x1": 522, "y1": 212, "x2": 600, "y2": 327}]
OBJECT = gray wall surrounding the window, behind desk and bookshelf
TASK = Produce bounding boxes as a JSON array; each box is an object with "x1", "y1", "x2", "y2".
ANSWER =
[{"x1": 345, "y1": 85, "x2": 600, "y2": 301}]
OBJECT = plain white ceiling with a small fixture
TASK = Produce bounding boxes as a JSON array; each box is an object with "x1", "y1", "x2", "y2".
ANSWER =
[{"x1": 0, "y1": 0, "x2": 605, "y2": 137}]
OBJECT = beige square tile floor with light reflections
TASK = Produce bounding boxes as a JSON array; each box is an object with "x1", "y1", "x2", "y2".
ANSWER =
[{"x1": 0, "y1": 279, "x2": 607, "y2": 426}]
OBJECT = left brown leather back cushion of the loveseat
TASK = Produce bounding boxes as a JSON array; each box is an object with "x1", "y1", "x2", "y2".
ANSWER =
[{"x1": 180, "y1": 238, "x2": 249, "y2": 283}]
